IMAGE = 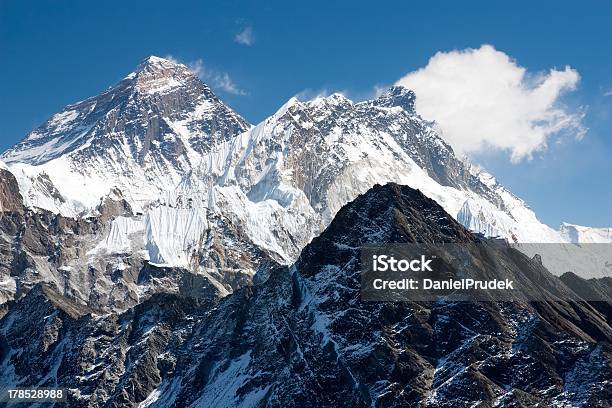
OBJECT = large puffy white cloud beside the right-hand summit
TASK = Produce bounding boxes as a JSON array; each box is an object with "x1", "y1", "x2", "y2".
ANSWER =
[{"x1": 397, "y1": 45, "x2": 586, "y2": 162}]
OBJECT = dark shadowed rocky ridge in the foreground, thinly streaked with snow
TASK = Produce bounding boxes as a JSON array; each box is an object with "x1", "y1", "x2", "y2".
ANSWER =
[{"x1": 0, "y1": 184, "x2": 612, "y2": 407}]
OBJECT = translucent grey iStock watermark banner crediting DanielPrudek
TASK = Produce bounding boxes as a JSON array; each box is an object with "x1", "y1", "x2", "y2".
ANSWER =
[{"x1": 361, "y1": 241, "x2": 608, "y2": 301}]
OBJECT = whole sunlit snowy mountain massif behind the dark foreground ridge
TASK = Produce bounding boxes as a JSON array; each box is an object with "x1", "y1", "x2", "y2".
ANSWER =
[{"x1": 2, "y1": 57, "x2": 610, "y2": 302}]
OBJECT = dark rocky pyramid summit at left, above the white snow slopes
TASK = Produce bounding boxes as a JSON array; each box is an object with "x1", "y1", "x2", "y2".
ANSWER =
[{"x1": 2, "y1": 56, "x2": 249, "y2": 165}]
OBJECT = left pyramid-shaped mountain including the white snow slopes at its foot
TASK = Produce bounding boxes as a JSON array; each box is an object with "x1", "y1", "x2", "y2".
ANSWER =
[{"x1": 2, "y1": 57, "x2": 250, "y2": 216}]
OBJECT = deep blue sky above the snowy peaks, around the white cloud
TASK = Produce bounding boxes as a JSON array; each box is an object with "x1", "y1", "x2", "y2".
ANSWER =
[{"x1": 0, "y1": 0, "x2": 612, "y2": 227}]
